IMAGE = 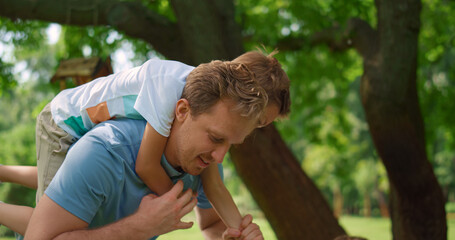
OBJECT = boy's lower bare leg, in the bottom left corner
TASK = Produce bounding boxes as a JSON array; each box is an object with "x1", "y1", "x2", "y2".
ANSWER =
[{"x1": 0, "y1": 202, "x2": 33, "y2": 235}]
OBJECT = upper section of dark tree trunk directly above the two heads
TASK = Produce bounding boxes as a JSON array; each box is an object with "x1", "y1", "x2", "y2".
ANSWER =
[{"x1": 170, "y1": 0, "x2": 244, "y2": 64}]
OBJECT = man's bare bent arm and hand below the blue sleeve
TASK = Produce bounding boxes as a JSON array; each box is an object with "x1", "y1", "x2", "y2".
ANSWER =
[{"x1": 25, "y1": 182, "x2": 196, "y2": 240}]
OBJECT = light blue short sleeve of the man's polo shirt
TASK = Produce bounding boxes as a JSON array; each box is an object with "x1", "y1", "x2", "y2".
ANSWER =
[{"x1": 45, "y1": 135, "x2": 123, "y2": 223}]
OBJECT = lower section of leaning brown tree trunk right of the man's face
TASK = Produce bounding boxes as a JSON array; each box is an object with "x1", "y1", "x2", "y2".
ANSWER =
[{"x1": 231, "y1": 126, "x2": 345, "y2": 240}]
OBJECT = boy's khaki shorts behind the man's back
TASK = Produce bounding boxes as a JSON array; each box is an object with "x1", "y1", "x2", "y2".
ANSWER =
[{"x1": 36, "y1": 103, "x2": 76, "y2": 203}]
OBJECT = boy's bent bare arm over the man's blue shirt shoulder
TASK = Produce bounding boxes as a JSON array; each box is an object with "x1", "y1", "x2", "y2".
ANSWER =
[{"x1": 135, "y1": 123, "x2": 173, "y2": 196}]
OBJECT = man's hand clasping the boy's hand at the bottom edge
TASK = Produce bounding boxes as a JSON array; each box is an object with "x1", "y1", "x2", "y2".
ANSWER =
[{"x1": 223, "y1": 214, "x2": 264, "y2": 240}]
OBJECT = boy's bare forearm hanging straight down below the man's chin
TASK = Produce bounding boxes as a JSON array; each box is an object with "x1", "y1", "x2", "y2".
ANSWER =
[{"x1": 201, "y1": 164, "x2": 242, "y2": 229}]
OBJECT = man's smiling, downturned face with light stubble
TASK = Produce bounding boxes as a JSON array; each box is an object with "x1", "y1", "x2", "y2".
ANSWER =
[{"x1": 164, "y1": 99, "x2": 257, "y2": 175}]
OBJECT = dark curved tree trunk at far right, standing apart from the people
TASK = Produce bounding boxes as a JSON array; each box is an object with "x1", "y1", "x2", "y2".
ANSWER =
[{"x1": 361, "y1": 0, "x2": 447, "y2": 237}]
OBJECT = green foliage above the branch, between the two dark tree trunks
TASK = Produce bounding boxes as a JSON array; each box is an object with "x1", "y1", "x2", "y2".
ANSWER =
[{"x1": 236, "y1": 0, "x2": 375, "y2": 50}]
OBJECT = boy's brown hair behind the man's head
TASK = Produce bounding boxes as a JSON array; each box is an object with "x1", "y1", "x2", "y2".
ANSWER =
[{"x1": 232, "y1": 51, "x2": 291, "y2": 117}]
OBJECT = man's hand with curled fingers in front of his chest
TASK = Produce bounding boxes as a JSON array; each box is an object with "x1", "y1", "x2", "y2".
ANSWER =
[{"x1": 135, "y1": 181, "x2": 197, "y2": 237}]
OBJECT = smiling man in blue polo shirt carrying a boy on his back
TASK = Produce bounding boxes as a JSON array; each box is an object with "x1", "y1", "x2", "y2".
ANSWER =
[{"x1": 25, "y1": 64, "x2": 279, "y2": 239}]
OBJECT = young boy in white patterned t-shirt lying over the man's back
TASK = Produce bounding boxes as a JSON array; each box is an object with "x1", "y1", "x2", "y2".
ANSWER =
[{"x1": 0, "y1": 52, "x2": 289, "y2": 232}]
